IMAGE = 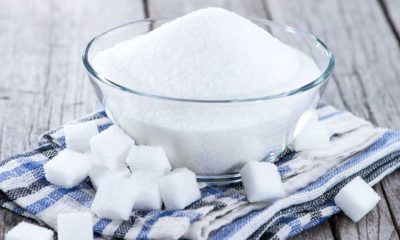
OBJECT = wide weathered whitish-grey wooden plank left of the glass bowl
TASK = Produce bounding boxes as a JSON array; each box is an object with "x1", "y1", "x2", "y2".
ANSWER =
[{"x1": 0, "y1": 0, "x2": 144, "y2": 239}]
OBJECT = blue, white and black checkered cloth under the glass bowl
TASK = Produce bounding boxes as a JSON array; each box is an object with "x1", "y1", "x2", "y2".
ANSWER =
[{"x1": 0, "y1": 106, "x2": 400, "y2": 239}]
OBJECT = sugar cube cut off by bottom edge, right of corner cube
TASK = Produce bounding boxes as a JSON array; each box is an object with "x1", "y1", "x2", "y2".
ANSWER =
[{"x1": 57, "y1": 212, "x2": 93, "y2": 240}]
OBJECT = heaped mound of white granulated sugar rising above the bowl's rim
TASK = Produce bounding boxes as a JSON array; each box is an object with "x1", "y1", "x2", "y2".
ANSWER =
[{"x1": 94, "y1": 8, "x2": 319, "y2": 99}]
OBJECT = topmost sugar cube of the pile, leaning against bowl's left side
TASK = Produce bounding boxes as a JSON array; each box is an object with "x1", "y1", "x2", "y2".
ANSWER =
[{"x1": 90, "y1": 125, "x2": 135, "y2": 169}]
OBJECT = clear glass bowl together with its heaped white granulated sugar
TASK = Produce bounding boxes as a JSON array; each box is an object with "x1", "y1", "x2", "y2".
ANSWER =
[{"x1": 83, "y1": 8, "x2": 335, "y2": 180}]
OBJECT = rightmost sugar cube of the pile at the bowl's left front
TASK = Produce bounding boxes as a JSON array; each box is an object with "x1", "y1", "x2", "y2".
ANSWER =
[{"x1": 159, "y1": 168, "x2": 201, "y2": 210}]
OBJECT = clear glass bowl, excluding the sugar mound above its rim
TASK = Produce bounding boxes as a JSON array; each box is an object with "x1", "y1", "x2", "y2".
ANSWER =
[{"x1": 83, "y1": 18, "x2": 335, "y2": 182}]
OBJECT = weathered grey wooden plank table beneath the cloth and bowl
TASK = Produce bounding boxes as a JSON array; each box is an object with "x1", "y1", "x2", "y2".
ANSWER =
[{"x1": 0, "y1": 0, "x2": 400, "y2": 240}]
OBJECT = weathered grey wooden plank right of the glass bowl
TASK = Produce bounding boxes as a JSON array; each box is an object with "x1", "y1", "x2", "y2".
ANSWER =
[{"x1": 265, "y1": 0, "x2": 400, "y2": 239}]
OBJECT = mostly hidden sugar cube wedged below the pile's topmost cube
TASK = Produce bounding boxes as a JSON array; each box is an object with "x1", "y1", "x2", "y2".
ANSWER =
[{"x1": 89, "y1": 166, "x2": 131, "y2": 189}]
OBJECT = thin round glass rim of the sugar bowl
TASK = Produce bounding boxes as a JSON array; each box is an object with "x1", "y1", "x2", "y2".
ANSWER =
[{"x1": 82, "y1": 16, "x2": 335, "y2": 103}]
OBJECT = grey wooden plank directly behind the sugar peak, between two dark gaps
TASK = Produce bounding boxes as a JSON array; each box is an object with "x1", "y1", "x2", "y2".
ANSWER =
[{"x1": 147, "y1": 0, "x2": 333, "y2": 239}]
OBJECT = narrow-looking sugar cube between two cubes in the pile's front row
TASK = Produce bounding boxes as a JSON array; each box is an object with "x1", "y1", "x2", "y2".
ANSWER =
[{"x1": 133, "y1": 178, "x2": 162, "y2": 210}]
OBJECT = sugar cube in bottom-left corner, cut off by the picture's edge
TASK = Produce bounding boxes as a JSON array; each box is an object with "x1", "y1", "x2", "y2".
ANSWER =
[{"x1": 5, "y1": 222, "x2": 53, "y2": 240}]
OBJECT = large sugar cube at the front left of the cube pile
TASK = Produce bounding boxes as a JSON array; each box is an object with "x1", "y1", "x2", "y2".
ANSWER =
[{"x1": 91, "y1": 178, "x2": 137, "y2": 220}]
